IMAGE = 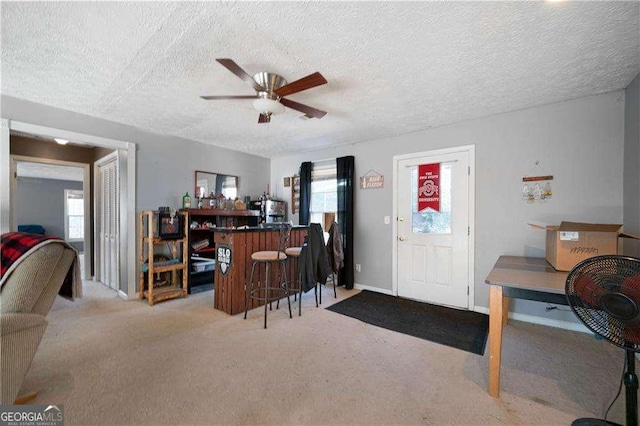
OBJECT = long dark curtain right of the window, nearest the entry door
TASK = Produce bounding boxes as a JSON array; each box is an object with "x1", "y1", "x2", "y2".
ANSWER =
[{"x1": 336, "y1": 155, "x2": 355, "y2": 289}]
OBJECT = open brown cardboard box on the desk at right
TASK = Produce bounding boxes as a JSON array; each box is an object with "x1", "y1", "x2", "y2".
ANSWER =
[{"x1": 530, "y1": 222, "x2": 640, "y2": 271}]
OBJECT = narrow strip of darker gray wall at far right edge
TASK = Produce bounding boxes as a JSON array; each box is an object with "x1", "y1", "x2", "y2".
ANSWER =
[{"x1": 624, "y1": 74, "x2": 640, "y2": 257}]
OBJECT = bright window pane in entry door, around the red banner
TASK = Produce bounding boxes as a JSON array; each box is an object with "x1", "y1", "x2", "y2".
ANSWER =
[{"x1": 411, "y1": 163, "x2": 452, "y2": 234}]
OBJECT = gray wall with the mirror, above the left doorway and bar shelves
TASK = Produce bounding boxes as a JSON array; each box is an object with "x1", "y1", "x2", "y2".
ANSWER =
[{"x1": 1, "y1": 96, "x2": 271, "y2": 292}]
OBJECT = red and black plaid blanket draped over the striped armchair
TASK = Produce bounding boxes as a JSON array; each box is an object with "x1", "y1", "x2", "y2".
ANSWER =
[{"x1": 0, "y1": 232, "x2": 82, "y2": 298}]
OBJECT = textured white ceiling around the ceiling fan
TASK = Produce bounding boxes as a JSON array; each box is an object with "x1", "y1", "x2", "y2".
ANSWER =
[{"x1": 0, "y1": 1, "x2": 640, "y2": 157}]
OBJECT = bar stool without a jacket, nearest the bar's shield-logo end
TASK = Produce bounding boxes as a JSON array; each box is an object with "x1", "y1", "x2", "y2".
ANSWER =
[{"x1": 244, "y1": 223, "x2": 293, "y2": 328}]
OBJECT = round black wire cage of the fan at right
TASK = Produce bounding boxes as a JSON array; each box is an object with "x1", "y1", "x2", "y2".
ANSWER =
[{"x1": 565, "y1": 255, "x2": 640, "y2": 352}]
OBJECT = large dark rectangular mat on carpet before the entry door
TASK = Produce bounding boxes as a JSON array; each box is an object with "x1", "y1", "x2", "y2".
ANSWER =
[{"x1": 327, "y1": 290, "x2": 489, "y2": 355}]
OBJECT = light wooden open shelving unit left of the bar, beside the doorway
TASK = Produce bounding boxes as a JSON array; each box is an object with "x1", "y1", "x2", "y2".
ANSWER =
[{"x1": 139, "y1": 211, "x2": 189, "y2": 306}]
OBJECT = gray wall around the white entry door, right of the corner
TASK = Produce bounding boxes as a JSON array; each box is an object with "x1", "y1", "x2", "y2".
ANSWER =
[{"x1": 271, "y1": 91, "x2": 624, "y2": 322}]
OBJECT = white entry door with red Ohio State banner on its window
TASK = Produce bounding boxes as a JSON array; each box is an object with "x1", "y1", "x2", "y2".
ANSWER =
[{"x1": 396, "y1": 147, "x2": 470, "y2": 309}]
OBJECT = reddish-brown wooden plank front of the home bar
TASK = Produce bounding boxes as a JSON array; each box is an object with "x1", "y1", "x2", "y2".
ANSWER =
[{"x1": 212, "y1": 226, "x2": 307, "y2": 315}]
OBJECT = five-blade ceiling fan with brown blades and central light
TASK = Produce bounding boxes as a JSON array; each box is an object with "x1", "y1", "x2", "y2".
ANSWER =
[{"x1": 200, "y1": 58, "x2": 327, "y2": 123}]
